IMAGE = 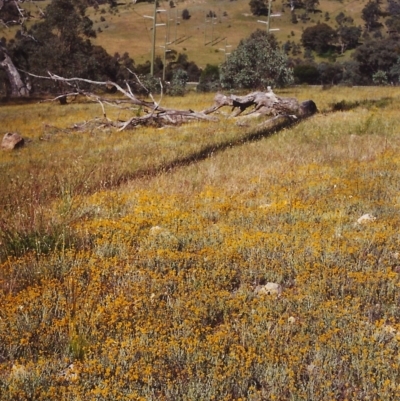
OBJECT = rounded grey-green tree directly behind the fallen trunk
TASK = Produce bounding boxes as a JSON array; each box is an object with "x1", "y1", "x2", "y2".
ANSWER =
[{"x1": 220, "y1": 30, "x2": 293, "y2": 89}]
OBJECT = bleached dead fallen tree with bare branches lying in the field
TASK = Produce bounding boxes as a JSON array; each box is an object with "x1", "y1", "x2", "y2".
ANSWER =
[{"x1": 29, "y1": 72, "x2": 317, "y2": 131}]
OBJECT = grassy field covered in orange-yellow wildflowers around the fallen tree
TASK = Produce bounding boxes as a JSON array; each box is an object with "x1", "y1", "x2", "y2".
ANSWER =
[{"x1": 0, "y1": 88, "x2": 400, "y2": 401}]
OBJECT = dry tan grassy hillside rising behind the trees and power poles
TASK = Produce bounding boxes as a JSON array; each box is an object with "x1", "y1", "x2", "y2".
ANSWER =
[{"x1": 90, "y1": 0, "x2": 378, "y2": 67}]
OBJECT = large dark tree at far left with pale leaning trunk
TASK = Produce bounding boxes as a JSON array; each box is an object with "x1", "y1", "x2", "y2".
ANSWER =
[{"x1": 0, "y1": 0, "x2": 134, "y2": 96}]
